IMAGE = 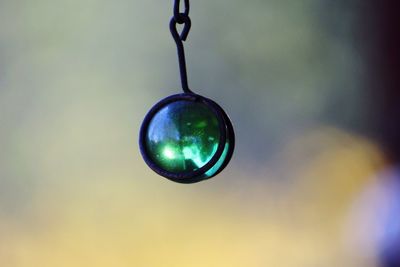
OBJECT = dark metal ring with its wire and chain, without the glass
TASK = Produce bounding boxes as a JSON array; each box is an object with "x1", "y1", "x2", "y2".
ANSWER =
[{"x1": 139, "y1": 0, "x2": 235, "y2": 184}]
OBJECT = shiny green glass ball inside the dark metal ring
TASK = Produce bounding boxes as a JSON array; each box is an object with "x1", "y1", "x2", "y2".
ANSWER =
[{"x1": 145, "y1": 100, "x2": 229, "y2": 178}]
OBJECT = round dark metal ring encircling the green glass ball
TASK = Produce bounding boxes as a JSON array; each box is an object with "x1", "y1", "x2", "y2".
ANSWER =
[{"x1": 139, "y1": 93, "x2": 235, "y2": 184}]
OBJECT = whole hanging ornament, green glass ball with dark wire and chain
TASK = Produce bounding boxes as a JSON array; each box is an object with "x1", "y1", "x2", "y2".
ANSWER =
[{"x1": 139, "y1": 0, "x2": 235, "y2": 184}]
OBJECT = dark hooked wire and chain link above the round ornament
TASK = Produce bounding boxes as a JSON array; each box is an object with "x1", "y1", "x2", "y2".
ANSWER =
[{"x1": 169, "y1": 0, "x2": 193, "y2": 93}]
